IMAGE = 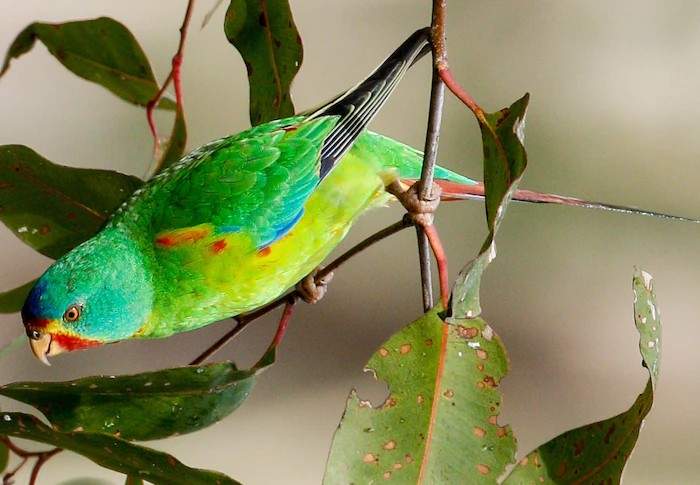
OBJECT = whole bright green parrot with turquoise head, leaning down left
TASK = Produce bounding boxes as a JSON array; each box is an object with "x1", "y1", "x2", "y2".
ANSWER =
[{"x1": 22, "y1": 29, "x2": 696, "y2": 363}]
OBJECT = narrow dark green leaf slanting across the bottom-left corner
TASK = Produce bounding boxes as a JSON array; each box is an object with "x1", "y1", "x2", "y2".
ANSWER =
[{"x1": 0, "y1": 413, "x2": 238, "y2": 485}]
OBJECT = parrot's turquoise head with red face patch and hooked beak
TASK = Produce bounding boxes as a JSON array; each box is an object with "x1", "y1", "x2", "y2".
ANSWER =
[{"x1": 22, "y1": 231, "x2": 153, "y2": 365}]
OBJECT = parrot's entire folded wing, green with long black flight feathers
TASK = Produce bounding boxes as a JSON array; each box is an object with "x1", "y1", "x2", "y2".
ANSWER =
[{"x1": 113, "y1": 29, "x2": 429, "y2": 247}]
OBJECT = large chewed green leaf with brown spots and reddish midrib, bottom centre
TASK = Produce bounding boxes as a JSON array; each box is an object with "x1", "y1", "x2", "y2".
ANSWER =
[{"x1": 324, "y1": 311, "x2": 515, "y2": 485}]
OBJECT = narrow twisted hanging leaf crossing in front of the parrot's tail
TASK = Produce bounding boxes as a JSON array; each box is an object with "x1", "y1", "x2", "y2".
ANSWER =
[{"x1": 451, "y1": 94, "x2": 530, "y2": 318}]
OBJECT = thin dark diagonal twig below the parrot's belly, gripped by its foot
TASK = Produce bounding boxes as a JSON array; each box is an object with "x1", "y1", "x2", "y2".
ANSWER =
[{"x1": 190, "y1": 217, "x2": 413, "y2": 365}]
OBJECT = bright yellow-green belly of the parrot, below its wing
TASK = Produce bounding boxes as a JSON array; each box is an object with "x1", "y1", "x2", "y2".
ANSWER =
[{"x1": 140, "y1": 147, "x2": 388, "y2": 338}]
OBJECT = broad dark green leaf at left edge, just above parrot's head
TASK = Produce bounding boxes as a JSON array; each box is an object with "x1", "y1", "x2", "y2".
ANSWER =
[{"x1": 0, "y1": 145, "x2": 143, "y2": 259}]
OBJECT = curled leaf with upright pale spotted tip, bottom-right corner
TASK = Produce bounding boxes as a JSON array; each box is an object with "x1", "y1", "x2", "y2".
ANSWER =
[{"x1": 504, "y1": 270, "x2": 661, "y2": 485}]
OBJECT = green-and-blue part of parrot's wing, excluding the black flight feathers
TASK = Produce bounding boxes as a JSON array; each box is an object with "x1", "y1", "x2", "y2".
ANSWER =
[{"x1": 146, "y1": 117, "x2": 337, "y2": 247}]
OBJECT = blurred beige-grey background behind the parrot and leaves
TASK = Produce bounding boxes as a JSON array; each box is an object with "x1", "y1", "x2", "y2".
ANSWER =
[{"x1": 0, "y1": 0, "x2": 700, "y2": 485}]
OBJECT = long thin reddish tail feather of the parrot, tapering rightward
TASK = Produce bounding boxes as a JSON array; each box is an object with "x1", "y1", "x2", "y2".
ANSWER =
[{"x1": 406, "y1": 180, "x2": 700, "y2": 223}]
